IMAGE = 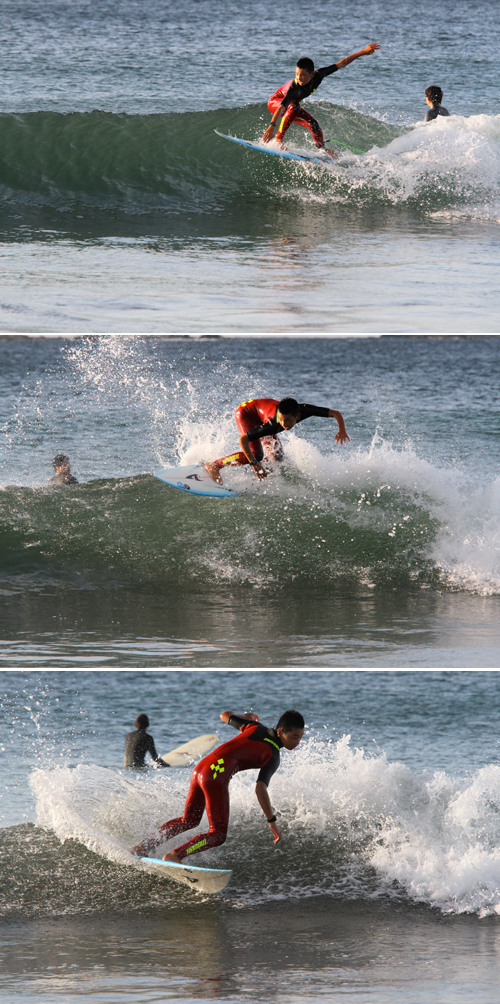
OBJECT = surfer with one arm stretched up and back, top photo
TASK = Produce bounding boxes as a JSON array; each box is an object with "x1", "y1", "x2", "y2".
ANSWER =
[{"x1": 262, "y1": 42, "x2": 381, "y2": 157}]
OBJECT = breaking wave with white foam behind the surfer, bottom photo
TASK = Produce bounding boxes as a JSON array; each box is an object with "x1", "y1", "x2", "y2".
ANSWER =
[{"x1": 0, "y1": 736, "x2": 500, "y2": 917}]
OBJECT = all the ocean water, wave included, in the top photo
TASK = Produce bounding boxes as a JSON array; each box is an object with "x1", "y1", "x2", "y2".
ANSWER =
[{"x1": 0, "y1": 0, "x2": 500, "y2": 334}]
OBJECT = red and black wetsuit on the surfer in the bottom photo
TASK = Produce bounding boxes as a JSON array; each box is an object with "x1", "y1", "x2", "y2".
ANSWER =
[{"x1": 145, "y1": 715, "x2": 283, "y2": 858}]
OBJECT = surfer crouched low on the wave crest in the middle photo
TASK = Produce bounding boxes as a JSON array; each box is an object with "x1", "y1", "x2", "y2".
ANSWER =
[{"x1": 205, "y1": 398, "x2": 350, "y2": 485}]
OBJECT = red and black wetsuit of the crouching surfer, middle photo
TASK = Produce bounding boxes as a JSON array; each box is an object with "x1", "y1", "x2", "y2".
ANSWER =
[{"x1": 213, "y1": 398, "x2": 329, "y2": 470}]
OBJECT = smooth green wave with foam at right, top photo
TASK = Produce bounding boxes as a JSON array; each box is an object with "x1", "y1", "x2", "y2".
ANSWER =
[{"x1": 0, "y1": 102, "x2": 500, "y2": 220}]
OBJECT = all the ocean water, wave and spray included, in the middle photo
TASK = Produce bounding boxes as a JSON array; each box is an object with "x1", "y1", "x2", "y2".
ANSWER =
[{"x1": 0, "y1": 335, "x2": 500, "y2": 669}]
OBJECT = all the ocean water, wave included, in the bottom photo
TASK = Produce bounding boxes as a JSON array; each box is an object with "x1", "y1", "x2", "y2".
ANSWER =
[{"x1": 0, "y1": 670, "x2": 500, "y2": 1004}]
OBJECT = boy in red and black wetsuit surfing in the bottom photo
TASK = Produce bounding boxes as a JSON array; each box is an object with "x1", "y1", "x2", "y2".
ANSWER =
[{"x1": 133, "y1": 711, "x2": 304, "y2": 862}]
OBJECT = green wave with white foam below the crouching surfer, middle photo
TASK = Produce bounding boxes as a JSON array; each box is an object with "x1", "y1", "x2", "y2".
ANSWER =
[{"x1": 0, "y1": 430, "x2": 500, "y2": 595}]
